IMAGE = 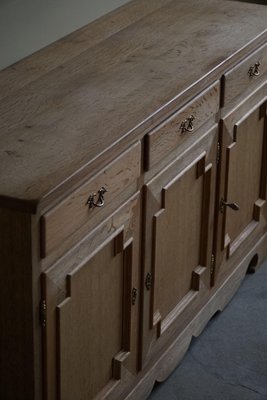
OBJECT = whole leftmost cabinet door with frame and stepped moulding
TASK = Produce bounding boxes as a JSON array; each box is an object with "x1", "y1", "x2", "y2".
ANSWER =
[{"x1": 42, "y1": 194, "x2": 140, "y2": 400}]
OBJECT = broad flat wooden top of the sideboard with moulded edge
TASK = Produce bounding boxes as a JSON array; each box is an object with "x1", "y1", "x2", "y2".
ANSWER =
[{"x1": 0, "y1": 0, "x2": 267, "y2": 210}]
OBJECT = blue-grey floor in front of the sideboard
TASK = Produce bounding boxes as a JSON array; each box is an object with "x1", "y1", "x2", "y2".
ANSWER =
[{"x1": 149, "y1": 261, "x2": 267, "y2": 400}]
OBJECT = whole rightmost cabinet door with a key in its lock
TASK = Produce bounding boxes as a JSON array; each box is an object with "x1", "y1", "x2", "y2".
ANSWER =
[{"x1": 217, "y1": 97, "x2": 267, "y2": 280}]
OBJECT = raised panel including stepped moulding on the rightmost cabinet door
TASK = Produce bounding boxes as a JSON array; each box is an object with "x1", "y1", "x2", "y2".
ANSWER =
[{"x1": 220, "y1": 103, "x2": 267, "y2": 258}]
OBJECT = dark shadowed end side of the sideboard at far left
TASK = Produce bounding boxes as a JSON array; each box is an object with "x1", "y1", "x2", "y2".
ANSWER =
[{"x1": 0, "y1": 208, "x2": 35, "y2": 399}]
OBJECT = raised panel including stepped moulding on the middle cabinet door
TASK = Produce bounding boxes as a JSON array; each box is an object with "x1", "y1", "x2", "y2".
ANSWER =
[{"x1": 153, "y1": 156, "x2": 211, "y2": 334}]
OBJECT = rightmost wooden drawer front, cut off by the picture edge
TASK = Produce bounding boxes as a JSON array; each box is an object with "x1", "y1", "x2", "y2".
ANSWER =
[{"x1": 222, "y1": 44, "x2": 267, "y2": 106}]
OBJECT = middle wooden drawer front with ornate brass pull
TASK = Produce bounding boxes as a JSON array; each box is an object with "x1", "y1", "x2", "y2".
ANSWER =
[{"x1": 145, "y1": 82, "x2": 220, "y2": 171}]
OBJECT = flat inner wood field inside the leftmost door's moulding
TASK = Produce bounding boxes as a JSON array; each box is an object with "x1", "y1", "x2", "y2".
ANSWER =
[{"x1": 57, "y1": 242, "x2": 124, "y2": 400}]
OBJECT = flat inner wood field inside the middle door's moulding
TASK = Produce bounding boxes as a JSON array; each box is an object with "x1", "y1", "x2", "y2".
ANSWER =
[{"x1": 154, "y1": 158, "x2": 203, "y2": 319}]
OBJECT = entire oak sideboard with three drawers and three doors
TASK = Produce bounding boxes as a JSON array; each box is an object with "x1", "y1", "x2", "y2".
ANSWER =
[{"x1": 0, "y1": 0, "x2": 267, "y2": 400}]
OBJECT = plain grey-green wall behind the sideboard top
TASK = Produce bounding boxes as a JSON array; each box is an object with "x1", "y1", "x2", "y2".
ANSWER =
[{"x1": 0, "y1": 0, "x2": 129, "y2": 70}]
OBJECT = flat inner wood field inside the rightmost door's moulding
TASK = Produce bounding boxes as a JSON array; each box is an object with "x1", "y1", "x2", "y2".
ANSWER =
[{"x1": 225, "y1": 108, "x2": 266, "y2": 256}]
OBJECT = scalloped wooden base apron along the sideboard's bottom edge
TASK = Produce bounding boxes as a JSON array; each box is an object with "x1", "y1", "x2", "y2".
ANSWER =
[{"x1": 124, "y1": 235, "x2": 267, "y2": 400}]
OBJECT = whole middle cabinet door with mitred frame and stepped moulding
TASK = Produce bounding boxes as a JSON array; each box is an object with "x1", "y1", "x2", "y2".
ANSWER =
[{"x1": 142, "y1": 127, "x2": 218, "y2": 363}]
